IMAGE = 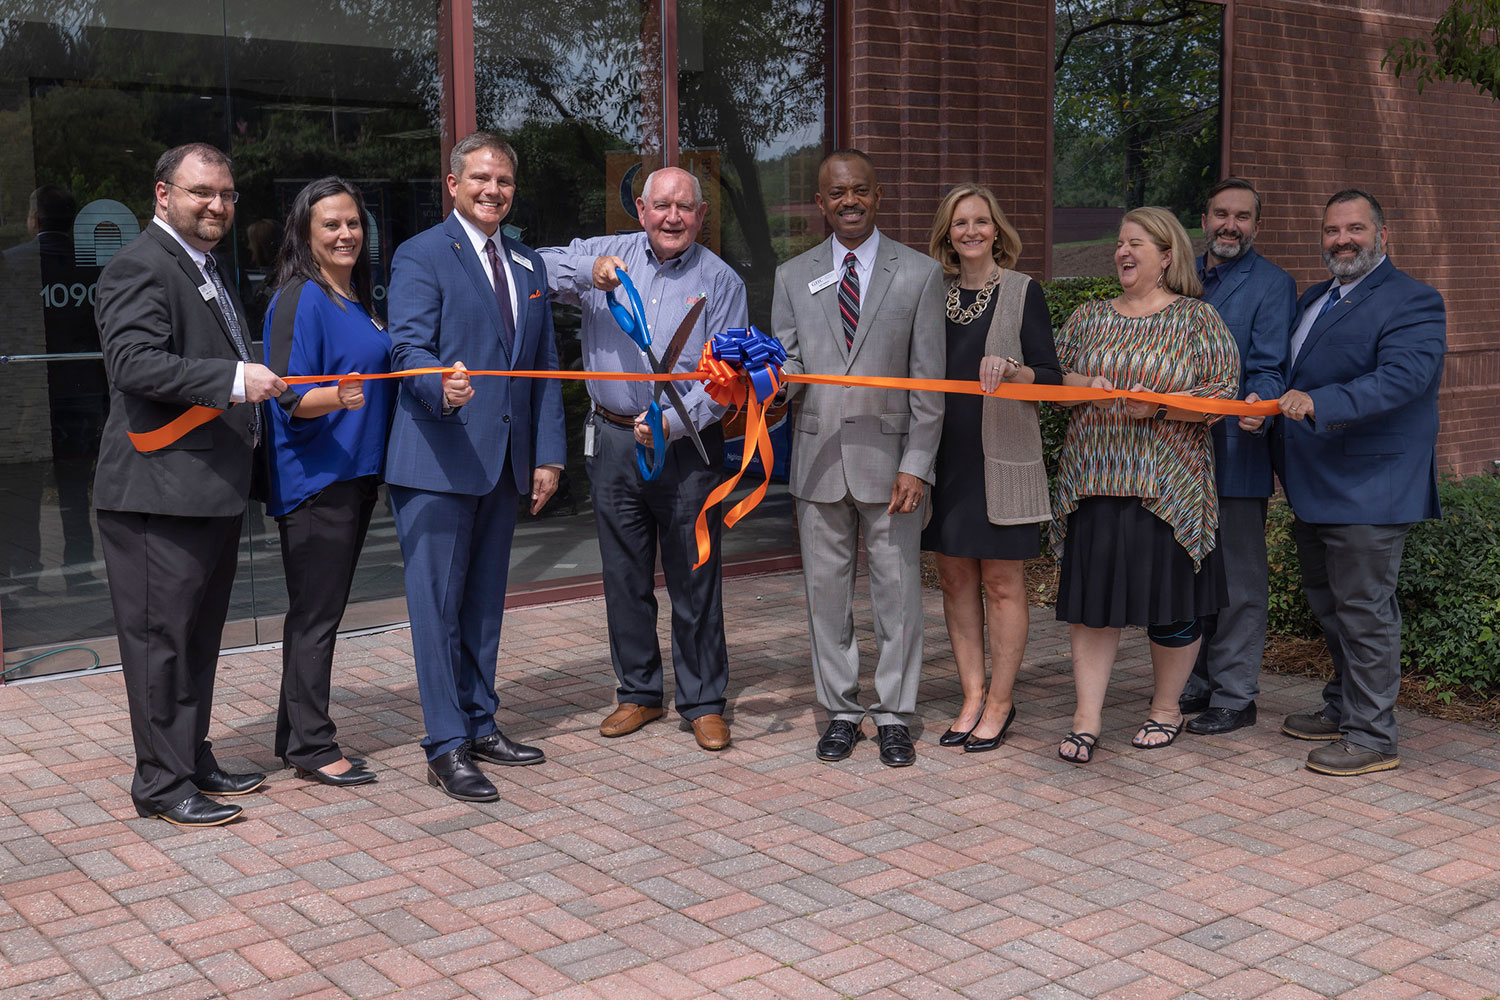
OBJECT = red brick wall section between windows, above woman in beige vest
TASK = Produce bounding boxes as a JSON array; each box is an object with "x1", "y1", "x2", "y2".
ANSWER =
[{"x1": 840, "y1": 0, "x2": 1052, "y2": 277}]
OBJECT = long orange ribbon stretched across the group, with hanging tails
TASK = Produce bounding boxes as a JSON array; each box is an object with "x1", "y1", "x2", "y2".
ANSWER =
[{"x1": 131, "y1": 367, "x2": 1281, "y2": 570}]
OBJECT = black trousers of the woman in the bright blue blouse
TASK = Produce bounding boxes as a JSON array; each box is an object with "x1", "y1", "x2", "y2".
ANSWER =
[{"x1": 276, "y1": 475, "x2": 378, "y2": 771}]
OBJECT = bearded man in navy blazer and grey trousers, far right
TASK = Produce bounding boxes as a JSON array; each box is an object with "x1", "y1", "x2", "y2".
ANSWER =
[{"x1": 1275, "y1": 189, "x2": 1448, "y2": 777}]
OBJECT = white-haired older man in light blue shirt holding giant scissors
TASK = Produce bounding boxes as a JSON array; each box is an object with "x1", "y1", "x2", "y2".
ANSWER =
[{"x1": 542, "y1": 166, "x2": 749, "y2": 750}]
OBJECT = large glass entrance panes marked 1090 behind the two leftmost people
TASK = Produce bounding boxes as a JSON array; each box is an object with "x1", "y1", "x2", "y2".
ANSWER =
[{"x1": 0, "y1": 0, "x2": 441, "y2": 676}]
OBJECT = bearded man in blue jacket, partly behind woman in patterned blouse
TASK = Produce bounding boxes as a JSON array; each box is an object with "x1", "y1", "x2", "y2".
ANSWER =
[{"x1": 1181, "y1": 177, "x2": 1298, "y2": 735}]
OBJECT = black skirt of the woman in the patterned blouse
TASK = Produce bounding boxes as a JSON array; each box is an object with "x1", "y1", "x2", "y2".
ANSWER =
[{"x1": 1058, "y1": 496, "x2": 1229, "y2": 628}]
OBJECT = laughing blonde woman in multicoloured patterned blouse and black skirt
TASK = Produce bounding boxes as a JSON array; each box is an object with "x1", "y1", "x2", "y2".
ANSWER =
[{"x1": 1050, "y1": 208, "x2": 1239, "y2": 765}]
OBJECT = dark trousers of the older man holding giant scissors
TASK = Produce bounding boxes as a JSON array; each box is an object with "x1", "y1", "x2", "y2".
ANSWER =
[{"x1": 588, "y1": 414, "x2": 729, "y2": 721}]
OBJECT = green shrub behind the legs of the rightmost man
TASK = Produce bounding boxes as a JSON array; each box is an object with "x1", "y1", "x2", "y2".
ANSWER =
[{"x1": 1266, "y1": 475, "x2": 1500, "y2": 697}]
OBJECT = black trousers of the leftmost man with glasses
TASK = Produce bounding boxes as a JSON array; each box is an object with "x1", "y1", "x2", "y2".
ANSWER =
[{"x1": 98, "y1": 510, "x2": 245, "y2": 813}]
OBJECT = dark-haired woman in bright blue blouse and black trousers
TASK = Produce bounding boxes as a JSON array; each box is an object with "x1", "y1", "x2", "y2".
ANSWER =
[{"x1": 264, "y1": 177, "x2": 395, "y2": 786}]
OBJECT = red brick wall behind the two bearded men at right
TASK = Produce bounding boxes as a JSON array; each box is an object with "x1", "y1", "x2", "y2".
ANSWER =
[{"x1": 1229, "y1": 0, "x2": 1500, "y2": 472}]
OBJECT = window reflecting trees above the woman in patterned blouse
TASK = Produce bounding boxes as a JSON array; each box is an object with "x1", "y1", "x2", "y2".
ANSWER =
[{"x1": 1052, "y1": 0, "x2": 1224, "y2": 277}]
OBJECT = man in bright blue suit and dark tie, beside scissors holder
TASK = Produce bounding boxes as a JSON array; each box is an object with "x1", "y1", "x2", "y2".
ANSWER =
[{"x1": 386, "y1": 132, "x2": 566, "y2": 802}]
